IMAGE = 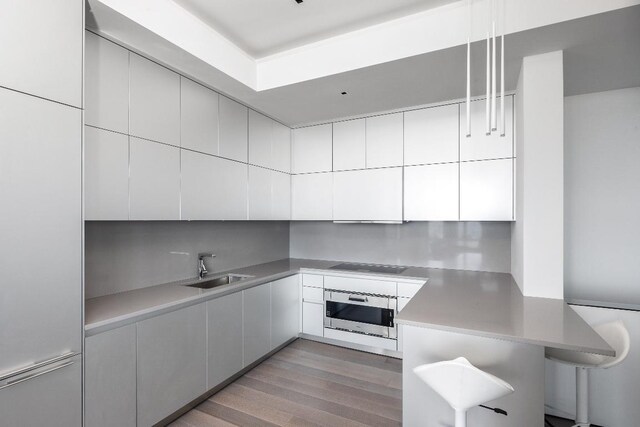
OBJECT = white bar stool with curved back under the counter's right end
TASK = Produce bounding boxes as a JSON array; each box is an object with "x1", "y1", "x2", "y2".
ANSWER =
[{"x1": 546, "y1": 320, "x2": 631, "y2": 427}]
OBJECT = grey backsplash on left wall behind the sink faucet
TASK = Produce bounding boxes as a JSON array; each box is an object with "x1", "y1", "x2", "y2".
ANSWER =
[{"x1": 85, "y1": 221, "x2": 289, "y2": 298}]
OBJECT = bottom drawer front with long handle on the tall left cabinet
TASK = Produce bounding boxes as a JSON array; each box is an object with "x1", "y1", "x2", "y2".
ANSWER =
[{"x1": 0, "y1": 355, "x2": 82, "y2": 427}]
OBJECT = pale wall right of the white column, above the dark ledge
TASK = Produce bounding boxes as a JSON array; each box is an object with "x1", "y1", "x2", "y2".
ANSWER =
[{"x1": 564, "y1": 87, "x2": 640, "y2": 308}]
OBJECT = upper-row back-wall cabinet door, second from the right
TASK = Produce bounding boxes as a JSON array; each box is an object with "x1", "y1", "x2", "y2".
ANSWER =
[{"x1": 404, "y1": 104, "x2": 459, "y2": 165}]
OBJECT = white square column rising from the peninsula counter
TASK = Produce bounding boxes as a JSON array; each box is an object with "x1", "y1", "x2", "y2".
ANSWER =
[{"x1": 511, "y1": 51, "x2": 564, "y2": 299}]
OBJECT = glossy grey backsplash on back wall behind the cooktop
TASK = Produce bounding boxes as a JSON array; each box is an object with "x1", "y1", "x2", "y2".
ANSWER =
[{"x1": 290, "y1": 221, "x2": 511, "y2": 273}]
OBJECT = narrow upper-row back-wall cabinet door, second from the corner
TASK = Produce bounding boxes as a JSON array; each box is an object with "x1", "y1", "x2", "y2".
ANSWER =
[{"x1": 333, "y1": 119, "x2": 366, "y2": 171}]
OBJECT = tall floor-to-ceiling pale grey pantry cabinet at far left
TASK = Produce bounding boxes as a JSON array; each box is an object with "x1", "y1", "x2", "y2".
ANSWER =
[{"x1": 0, "y1": 0, "x2": 84, "y2": 426}]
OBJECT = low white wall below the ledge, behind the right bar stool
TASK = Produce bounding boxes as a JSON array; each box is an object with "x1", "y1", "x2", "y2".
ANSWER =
[{"x1": 545, "y1": 306, "x2": 640, "y2": 427}]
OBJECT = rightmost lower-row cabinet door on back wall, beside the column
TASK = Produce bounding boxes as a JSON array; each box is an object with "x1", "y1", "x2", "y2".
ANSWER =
[{"x1": 460, "y1": 159, "x2": 513, "y2": 221}]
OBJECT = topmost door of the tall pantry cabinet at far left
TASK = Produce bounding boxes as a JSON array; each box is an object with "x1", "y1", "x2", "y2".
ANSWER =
[{"x1": 0, "y1": 0, "x2": 84, "y2": 107}]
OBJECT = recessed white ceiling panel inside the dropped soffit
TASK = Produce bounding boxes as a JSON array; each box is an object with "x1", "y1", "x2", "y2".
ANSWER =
[{"x1": 173, "y1": 0, "x2": 457, "y2": 58}]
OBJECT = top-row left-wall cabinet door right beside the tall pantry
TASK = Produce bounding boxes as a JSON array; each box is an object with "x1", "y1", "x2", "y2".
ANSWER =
[{"x1": 84, "y1": 31, "x2": 129, "y2": 133}]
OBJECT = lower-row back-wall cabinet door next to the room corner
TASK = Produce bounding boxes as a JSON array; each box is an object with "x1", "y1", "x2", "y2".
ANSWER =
[{"x1": 291, "y1": 172, "x2": 333, "y2": 221}]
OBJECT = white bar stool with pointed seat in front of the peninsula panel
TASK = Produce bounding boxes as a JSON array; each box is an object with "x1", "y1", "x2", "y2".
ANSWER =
[{"x1": 413, "y1": 357, "x2": 513, "y2": 427}]
